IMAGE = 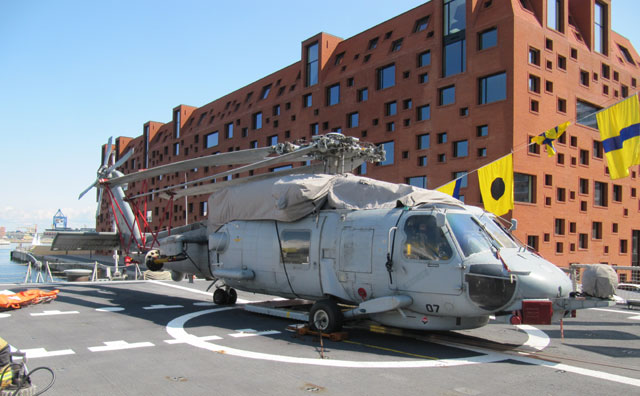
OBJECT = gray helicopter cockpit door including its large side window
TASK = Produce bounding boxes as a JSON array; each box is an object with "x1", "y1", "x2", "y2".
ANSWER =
[{"x1": 393, "y1": 214, "x2": 463, "y2": 295}]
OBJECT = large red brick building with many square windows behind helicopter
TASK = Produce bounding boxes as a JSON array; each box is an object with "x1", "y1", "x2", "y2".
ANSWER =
[{"x1": 98, "y1": 0, "x2": 640, "y2": 272}]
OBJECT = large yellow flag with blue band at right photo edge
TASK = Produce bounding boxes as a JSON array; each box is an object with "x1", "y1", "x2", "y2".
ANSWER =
[{"x1": 596, "y1": 95, "x2": 640, "y2": 179}]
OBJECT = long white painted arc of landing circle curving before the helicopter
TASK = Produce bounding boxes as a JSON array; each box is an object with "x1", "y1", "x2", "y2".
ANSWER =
[{"x1": 167, "y1": 307, "x2": 505, "y2": 368}]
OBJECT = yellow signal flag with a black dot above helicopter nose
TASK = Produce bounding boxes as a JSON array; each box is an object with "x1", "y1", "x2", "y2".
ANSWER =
[{"x1": 478, "y1": 154, "x2": 513, "y2": 216}]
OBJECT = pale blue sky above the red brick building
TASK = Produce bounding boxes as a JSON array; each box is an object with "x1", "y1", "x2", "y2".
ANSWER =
[{"x1": 0, "y1": 0, "x2": 640, "y2": 230}]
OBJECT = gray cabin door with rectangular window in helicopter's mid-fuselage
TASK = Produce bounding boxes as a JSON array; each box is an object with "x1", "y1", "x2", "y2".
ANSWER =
[{"x1": 278, "y1": 219, "x2": 322, "y2": 298}]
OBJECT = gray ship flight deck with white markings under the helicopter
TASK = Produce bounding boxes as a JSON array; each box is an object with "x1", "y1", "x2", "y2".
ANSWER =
[{"x1": 0, "y1": 280, "x2": 640, "y2": 395}]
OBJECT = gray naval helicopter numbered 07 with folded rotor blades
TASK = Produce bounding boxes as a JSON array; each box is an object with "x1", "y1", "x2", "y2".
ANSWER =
[{"x1": 53, "y1": 134, "x2": 612, "y2": 332}]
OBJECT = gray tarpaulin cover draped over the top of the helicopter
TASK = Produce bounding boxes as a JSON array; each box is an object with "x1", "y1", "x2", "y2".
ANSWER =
[{"x1": 208, "y1": 174, "x2": 463, "y2": 227}]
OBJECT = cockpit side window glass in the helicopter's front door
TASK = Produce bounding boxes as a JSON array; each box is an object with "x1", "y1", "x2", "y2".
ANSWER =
[{"x1": 403, "y1": 215, "x2": 452, "y2": 261}]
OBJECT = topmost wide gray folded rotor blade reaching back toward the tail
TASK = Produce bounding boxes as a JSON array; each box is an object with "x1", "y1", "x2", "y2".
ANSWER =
[{"x1": 109, "y1": 146, "x2": 275, "y2": 184}]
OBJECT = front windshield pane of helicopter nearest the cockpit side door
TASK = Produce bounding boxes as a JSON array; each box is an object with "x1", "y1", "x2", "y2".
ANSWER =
[{"x1": 447, "y1": 212, "x2": 496, "y2": 257}]
